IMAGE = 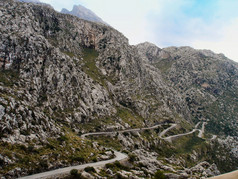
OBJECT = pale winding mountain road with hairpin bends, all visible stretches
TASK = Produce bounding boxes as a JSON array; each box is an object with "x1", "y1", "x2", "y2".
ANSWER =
[{"x1": 19, "y1": 122, "x2": 205, "y2": 179}]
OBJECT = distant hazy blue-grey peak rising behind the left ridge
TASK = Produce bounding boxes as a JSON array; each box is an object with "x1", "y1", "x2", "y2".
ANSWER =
[{"x1": 61, "y1": 5, "x2": 107, "y2": 25}]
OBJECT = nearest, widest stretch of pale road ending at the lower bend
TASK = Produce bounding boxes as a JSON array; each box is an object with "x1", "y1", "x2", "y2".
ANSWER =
[{"x1": 20, "y1": 151, "x2": 128, "y2": 179}]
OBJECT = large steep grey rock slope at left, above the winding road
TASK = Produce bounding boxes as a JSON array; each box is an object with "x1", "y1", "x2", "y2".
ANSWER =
[{"x1": 1, "y1": 1, "x2": 192, "y2": 142}]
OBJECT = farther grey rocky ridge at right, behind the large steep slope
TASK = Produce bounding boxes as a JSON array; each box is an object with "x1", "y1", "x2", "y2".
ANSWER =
[{"x1": 137, "y1": 43, "x2": 238, "y2": 136}]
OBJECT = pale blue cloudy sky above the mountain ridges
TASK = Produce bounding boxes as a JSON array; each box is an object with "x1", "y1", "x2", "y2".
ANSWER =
[{"x1": 41, "y1": 0, "x2": 238, "y2": 62}]
